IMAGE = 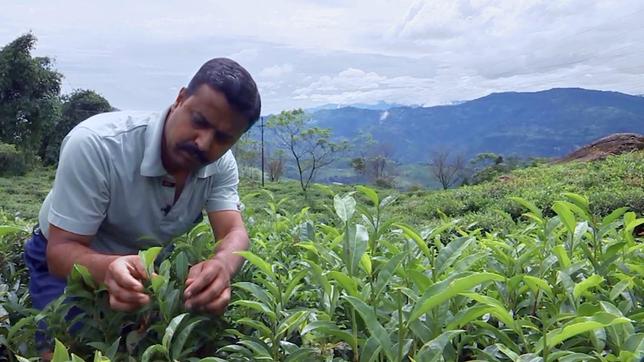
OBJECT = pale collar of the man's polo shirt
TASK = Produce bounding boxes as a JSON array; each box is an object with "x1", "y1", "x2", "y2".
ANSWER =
[{"x1": 141, "y1": 108, "x2": 223, "y2": 178}]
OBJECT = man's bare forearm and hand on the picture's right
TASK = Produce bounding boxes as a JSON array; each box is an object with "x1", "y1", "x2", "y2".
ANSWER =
[{"x1": 184, "y1": 211, "x2": 249, "y2": 314}]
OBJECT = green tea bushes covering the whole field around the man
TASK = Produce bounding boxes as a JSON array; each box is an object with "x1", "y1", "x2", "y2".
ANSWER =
[{"x1": 0, "y1": 153, "x2": 644, "y2": 361}]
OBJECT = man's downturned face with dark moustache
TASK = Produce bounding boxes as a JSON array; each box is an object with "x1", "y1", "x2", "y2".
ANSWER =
[{"x1": 161, "y1": 84, "x2": 248, "y2": 173}]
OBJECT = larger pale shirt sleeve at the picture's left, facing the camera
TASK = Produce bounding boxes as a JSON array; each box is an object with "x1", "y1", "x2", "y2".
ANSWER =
[{"x1": 47, "y1": 127, "x2": 110, "y2": 235}]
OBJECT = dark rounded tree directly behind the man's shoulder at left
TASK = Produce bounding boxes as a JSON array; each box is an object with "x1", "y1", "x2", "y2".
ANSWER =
[{"x1": 39, "y1": 89, "x2": 114, "y2": 165}]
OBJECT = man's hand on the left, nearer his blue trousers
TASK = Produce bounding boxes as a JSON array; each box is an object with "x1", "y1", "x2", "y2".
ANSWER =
[{"x1": 104, "y1": 255, "x2": 150, "y2": 312}]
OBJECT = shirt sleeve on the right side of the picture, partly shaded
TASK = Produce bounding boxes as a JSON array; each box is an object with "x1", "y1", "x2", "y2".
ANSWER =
[{"x1": 206, "y1": 151, "x2": 241, "y2": 212}]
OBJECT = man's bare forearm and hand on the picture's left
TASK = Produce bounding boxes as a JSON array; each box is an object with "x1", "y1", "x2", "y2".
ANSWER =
[{"x1": 47, "y1": 224, "x2": 150, "y2": 310}]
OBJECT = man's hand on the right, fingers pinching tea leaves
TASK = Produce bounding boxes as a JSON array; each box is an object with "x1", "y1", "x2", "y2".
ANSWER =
[{"x1": 183, "y1": 259, "x2": 232, "y2": 315}]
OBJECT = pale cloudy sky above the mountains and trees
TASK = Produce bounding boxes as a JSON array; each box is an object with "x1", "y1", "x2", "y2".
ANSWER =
[{"x1": 0, "y1": 0, "x2": 644, "y2": 114}]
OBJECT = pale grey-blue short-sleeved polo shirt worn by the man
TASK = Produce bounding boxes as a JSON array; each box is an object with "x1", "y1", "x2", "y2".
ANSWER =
[{"x1": 39, "y1": 110, "x2": 239, "y2": 254}]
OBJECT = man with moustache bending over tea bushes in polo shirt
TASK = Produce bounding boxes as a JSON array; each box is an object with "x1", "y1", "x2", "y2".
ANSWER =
[{"x1": 25, "y1": 58, "x2": 261, "y2": 320}]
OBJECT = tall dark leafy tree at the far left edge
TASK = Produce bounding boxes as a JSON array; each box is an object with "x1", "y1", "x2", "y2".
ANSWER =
[{"x1": 0, "y1": 33, "x2": 62, "y2": 155}]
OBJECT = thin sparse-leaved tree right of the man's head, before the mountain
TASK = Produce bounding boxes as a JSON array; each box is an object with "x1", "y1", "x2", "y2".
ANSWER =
[{"x1": 267, "y1": 109, "x2": 347, "y2": 193}]
